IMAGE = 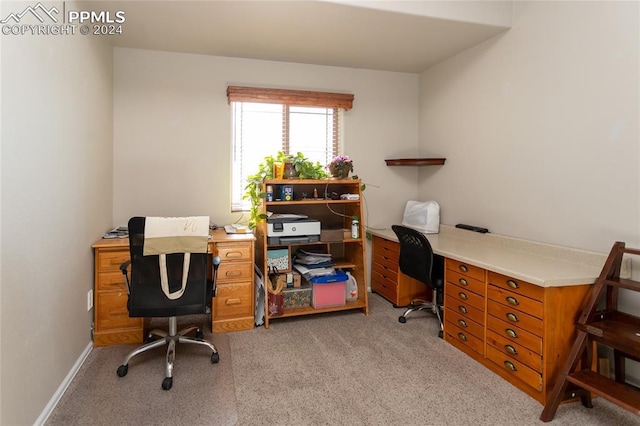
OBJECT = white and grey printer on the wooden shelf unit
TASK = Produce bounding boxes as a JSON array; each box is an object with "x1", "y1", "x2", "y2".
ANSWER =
[{"x1": 267, "y1": 214, "x2": 320, "y2": 244}]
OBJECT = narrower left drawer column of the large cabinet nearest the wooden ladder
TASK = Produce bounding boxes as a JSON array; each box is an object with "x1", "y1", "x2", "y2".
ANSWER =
[{"x1": 444, "y1": 259, "x2": 486, "y2": 356}]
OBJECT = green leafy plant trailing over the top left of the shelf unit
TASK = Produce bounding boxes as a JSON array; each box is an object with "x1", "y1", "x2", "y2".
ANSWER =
[{"x1": 243, "y1": 151, "x2": 329, "y2": 228}]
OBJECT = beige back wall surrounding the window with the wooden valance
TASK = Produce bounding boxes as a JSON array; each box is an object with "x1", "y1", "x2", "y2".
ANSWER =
[{"x1": 113, "y1": 48, "x2": 419, "y2": 230}]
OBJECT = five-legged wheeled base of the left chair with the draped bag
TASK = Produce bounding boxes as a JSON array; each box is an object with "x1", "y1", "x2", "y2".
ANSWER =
[{"x1": 117, "y1": 317, "x2": 220, "y2": 390}]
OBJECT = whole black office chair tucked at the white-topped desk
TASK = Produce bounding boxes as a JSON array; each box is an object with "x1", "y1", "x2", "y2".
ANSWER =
[{"x1": 391, "y1": 225, "x2": 444, "y2": 337}]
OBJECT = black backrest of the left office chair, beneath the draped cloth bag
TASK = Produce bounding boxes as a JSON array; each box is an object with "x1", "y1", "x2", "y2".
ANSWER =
[{"x1": 127, "y1": 217, "x2": 211, "y2": 317}]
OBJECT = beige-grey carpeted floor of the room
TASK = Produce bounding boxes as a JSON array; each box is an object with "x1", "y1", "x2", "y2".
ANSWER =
[{"x1": 47, "y1": 294, "x2": 640, "y2": 426}]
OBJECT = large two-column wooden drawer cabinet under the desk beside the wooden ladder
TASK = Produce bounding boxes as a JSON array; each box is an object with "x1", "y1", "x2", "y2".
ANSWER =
[{"x1": 444, "y1": 258, "x2": 590, "y2": 404}]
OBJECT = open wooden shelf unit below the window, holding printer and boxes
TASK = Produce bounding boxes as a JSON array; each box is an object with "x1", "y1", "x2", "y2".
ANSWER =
[{"x1": 255, "y1": 179, "x2": 369, "y2": 328}]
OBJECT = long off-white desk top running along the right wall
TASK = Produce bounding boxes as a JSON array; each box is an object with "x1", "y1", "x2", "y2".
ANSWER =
[{"x1": 367, "y1": 225, "x2": 631, "y2": 287}]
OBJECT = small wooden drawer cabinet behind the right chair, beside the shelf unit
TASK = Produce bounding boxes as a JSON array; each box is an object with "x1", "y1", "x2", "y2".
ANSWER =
[{"x1": 371, "y1": 235, "x2": 424, "y2": 307}]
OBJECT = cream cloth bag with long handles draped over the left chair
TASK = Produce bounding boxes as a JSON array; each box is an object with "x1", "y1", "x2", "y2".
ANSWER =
[{"x1": 143, "y1": 216, "x2": 209, "y2": 300}]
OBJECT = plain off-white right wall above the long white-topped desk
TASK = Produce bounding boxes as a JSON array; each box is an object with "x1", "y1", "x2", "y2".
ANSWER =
[{"x1": 419, "y1": 2, "x2": 640, "y2": 382}]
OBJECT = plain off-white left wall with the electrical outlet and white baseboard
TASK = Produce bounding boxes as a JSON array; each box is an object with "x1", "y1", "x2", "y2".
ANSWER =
[{"x1": 0, "y1": 13, "x2": 112, "y2": 425}]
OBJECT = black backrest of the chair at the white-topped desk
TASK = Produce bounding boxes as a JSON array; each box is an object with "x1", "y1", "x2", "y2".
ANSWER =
[{"x1": 391, "y1": 225, "x2": 443, "y2": 288}]
